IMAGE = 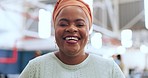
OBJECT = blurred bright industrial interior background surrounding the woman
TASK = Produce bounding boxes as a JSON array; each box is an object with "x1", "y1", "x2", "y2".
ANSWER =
[{"x1": 0, "y1": 0, "x2": 148, "y2": 78}]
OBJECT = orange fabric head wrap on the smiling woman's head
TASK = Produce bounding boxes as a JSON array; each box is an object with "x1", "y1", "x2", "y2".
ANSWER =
[{"x1": 52, "y1": 0, "x2": 92, "y2": 27}]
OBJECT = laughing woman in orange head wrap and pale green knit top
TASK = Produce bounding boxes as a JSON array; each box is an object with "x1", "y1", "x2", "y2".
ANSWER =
[{"x1": 19, "y1": 0, "x2": 124, "y2": 78}]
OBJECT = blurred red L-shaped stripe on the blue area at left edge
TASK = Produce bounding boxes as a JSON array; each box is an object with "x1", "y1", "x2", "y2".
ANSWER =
[{"x1": 0, "y1": 45, "x2": 18, "y2": 64}]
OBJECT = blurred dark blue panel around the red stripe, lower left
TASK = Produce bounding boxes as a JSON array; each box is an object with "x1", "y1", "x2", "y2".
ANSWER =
[{"x1": 0, "y1": 50, "x2": 35, "y2": 74}]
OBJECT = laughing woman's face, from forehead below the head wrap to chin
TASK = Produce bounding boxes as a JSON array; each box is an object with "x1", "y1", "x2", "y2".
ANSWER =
[{"x1": 54, "y1": 6, "x2": 89, "y2": 56}]
